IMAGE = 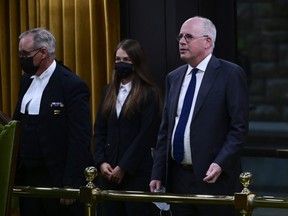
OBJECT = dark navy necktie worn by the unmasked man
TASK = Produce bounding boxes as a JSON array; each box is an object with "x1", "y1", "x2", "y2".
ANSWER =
[{"x1": 173, "y1": 68, "x2": 198, "y2": 164}]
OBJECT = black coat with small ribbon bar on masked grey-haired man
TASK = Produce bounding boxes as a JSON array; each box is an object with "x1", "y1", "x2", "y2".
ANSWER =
[{"x1": 13, "y1": 63, "x2": 92, "y2": 187}]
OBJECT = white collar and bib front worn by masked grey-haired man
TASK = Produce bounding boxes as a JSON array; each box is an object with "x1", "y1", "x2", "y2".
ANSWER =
[{"x1": 20, "y1": 60, "x2": 56, "y2": 115}]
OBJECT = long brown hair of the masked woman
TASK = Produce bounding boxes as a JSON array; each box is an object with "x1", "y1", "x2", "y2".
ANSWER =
[{"x1": 102, "y1": 39, "x2": 162, "y2": 117}]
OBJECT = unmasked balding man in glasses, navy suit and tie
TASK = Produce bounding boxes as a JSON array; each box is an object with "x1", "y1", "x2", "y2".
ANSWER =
[{"x1": 150, "y1": 17, "x2": 248, "y2": 216}]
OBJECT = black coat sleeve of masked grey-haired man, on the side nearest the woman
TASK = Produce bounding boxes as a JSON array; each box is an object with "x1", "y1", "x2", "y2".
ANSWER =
[{"x1": 64, "y1": 77, "x2": 92, "y2": 186}]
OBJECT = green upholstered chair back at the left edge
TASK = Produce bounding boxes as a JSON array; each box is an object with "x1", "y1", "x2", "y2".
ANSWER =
[{"x1": 0, "y1": 112, "x2": 19, "y2": 216}]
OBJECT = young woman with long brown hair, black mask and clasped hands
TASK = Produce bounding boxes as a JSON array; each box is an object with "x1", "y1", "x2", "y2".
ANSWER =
[{"x1": 94, "y1": 39, "x2": 162, "y2": 216}]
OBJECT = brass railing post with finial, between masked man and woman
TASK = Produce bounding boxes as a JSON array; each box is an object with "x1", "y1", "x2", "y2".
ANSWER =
[{"x1": 79, "y1": 167, "x2": 97, "y2": 216}]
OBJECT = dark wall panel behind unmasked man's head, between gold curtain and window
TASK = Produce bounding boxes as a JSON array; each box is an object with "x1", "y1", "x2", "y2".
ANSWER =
[{"x1": 120, "y1": 0, "x2": 237, "y2": 90}]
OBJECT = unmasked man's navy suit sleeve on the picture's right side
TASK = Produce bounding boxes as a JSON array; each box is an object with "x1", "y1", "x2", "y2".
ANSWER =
[{"x1": 215, "y1": 66, "x2": 249, "y2": 173}]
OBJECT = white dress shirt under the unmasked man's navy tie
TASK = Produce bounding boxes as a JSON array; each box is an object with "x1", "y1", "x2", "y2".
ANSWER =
[{"x1": 171, "y1": 54, "x2": 212, "y2": 165}]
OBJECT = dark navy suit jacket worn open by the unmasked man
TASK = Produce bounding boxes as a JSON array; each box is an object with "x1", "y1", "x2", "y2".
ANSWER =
[{"x1": 152, "y1": 55, "x2": 249, "y2": 194}]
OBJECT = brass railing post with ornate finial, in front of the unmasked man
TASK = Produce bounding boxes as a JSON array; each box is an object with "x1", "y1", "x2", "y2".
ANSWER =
[{"x1": 234, "y1": 172, "x2": 255, "y2": 216}]
